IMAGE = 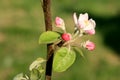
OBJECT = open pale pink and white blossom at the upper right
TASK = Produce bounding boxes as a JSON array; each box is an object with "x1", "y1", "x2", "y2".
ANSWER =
[{"x1": 73, "y1": 13, "x2": 96, "y2": 35}]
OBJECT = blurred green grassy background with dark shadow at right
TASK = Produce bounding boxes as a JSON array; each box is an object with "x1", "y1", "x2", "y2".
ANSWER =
[{"x1": 0, "y1": 0, "x2": 120, "y2": 80}]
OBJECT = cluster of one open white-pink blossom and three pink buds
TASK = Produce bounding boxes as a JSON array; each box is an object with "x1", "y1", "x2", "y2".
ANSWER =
[{"x1": 55, "y1": 13, "x2": 96, "y2": 51}]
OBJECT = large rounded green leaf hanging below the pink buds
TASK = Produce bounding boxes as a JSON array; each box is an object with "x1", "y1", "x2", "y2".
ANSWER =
[{"x1": 53, "y1": 47, "x2": 76, "y2": 72}]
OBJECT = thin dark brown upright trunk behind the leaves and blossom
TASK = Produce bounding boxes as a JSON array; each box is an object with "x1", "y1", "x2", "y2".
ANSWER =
[{"x1": 42, "y1": 0, "x2": 53, "y2": 80}]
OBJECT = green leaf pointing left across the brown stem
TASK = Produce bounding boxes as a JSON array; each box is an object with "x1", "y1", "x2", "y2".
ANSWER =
[{"x1": 39, "y1": 31, "x2": 60, "y2": 44}]
